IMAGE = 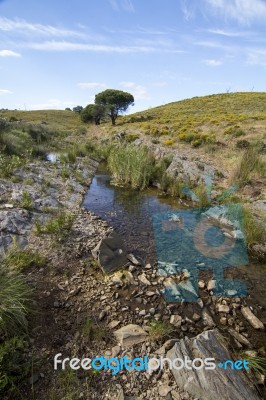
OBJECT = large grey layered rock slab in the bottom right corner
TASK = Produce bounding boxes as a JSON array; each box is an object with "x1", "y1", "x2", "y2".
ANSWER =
[{"x1": 166, "y1": 330, "x2": 259, "y2": 400}]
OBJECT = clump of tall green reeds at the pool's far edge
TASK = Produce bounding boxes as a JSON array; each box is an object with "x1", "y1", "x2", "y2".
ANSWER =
[{"x1": 107, "y1": 144, "x2": 154, "y2": 189}]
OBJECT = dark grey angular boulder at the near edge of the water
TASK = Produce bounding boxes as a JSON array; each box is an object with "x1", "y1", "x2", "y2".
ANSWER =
[{"x1": 92, "y1": 231, "x2": 128, "y2": 274}]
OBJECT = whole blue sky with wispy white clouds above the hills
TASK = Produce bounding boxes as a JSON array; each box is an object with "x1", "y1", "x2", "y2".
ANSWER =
[{"x1": 0, "y1": 0, "x2": 266, "y2": 112}]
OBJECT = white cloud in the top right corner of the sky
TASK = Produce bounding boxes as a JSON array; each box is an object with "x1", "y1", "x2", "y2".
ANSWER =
[{"x1": 205, "y1": 0, "x2": 266, "y2": 25}]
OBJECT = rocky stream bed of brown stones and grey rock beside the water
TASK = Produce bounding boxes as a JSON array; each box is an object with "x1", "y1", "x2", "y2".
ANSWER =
[{"x1": 0, "y1": 152, "x2": 266, "y2": 400}]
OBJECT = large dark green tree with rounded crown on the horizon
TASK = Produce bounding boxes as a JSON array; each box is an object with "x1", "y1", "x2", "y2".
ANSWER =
[{"x1": 95, "y1": 89, "x2": 134, "y2": 125}]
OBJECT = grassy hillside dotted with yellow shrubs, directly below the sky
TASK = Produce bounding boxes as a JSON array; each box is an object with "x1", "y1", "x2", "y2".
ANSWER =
[{"x1": 0, "y1": 92, "x2": 266, "y2": 179}]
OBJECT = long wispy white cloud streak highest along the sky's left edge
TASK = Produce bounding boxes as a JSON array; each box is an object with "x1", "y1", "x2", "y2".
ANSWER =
[{"x1": 0, "y1": 17, "x2": 85, "y2": 37}]
